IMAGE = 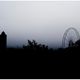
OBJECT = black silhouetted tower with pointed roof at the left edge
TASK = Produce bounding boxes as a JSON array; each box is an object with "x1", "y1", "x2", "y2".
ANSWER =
[{"x1": 0, "y1": 31, "x2": 7, "y2": 49}]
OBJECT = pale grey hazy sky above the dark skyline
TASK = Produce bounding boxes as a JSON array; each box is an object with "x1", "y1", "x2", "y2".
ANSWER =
[{"x1": 0, "y1": 1, "x2": 80, "y2": 47}]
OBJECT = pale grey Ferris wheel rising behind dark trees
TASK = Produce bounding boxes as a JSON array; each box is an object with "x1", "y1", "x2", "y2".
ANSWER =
[{"x1": 62, "y1": 27, "x2": 80, "y2": 48}]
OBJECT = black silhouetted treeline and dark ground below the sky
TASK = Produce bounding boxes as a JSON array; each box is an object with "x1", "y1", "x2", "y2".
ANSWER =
[{"x1": 0, "y1": 40, "x2": 80, "y2": 79}]
